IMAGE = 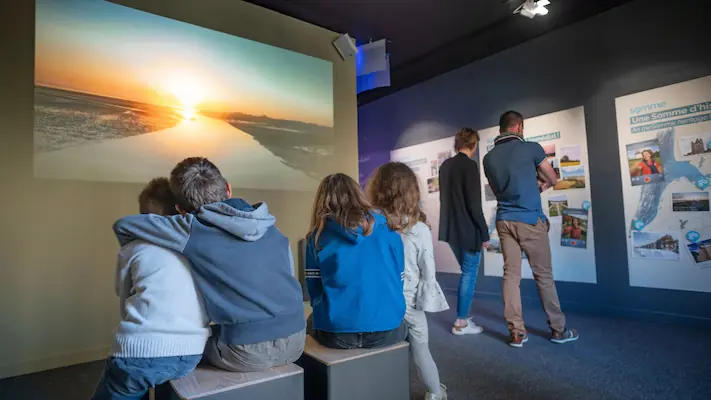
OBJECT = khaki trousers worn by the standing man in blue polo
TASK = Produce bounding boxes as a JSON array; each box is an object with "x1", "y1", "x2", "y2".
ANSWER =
[{"x1": 496, "y1": 219, "x2": 565, "y2": 333}]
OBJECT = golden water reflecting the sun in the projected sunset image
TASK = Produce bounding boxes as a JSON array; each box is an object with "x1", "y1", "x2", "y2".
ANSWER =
[{"x1": 34, "y1": 115, "x2": 318, "y2": 190}]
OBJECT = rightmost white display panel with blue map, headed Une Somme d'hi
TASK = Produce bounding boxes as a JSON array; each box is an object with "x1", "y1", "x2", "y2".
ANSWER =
[{"x1": 615, "y1": 76, "x2": 711, "y2": 292}]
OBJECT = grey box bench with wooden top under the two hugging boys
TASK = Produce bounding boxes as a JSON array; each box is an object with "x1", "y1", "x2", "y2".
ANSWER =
[{"x1": 163, "y1": 364, "x2": 304, "y2": 400}]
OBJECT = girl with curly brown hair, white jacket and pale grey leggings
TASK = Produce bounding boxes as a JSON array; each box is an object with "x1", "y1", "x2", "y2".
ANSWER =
[{"x1": 367, "y1": 162, "x2": 449, "y2": 400}]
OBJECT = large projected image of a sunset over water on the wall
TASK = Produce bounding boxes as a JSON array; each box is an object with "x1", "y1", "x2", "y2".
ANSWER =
[{"x1": 34, "y1": 0, "x2": 334, "y2": 190}]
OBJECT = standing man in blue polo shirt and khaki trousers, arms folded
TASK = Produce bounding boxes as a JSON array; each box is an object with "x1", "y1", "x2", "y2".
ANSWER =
[{"x1": 483, "y1": 111, "x2": 579, "y2": 347}]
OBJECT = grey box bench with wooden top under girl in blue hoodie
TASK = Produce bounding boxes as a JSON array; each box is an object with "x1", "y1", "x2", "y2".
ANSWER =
[{"x1": 297, "y1": 336, "x2": 410, "y2": 400}]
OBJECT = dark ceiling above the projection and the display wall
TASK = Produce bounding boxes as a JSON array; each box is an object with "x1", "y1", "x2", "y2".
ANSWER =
[{"x1": 247, "y1": 0, "x2": 642, "y2": 105}]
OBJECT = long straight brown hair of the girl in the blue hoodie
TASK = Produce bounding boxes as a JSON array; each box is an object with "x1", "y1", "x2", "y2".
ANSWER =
[{"x1": 309, "y1": 173, "x2": 375, "y2": 248}]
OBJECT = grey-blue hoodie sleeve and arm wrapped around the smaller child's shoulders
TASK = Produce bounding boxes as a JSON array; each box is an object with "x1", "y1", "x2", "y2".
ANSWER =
[{"x1": 114, "y1": 214, "x2": 195, "y2": 253}]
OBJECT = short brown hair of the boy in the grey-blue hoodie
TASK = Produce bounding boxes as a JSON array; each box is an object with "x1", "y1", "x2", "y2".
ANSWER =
[{"x1": 170, "y1": 157, "x2": 229, "y2": 213}]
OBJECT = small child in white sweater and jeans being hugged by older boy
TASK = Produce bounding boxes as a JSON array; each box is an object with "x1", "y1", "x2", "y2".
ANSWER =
[{"x1": 93, "y1": 178, "x2": 210, "y2": 400}]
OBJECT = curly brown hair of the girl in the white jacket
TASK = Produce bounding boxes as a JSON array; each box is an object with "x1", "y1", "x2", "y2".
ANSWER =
[{"x1": 366, "y1": 162, "x2": 427, "y2": 232}]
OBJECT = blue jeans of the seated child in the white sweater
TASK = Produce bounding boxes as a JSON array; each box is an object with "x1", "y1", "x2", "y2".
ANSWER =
[{"x1": 92, "y1": 354, "x2": 202, "y2": 400}]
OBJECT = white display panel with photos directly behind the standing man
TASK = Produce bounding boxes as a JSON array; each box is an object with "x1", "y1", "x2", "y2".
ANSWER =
[{"x1": 479, "y1": 107, "x2": 597, "y2": 283}]
